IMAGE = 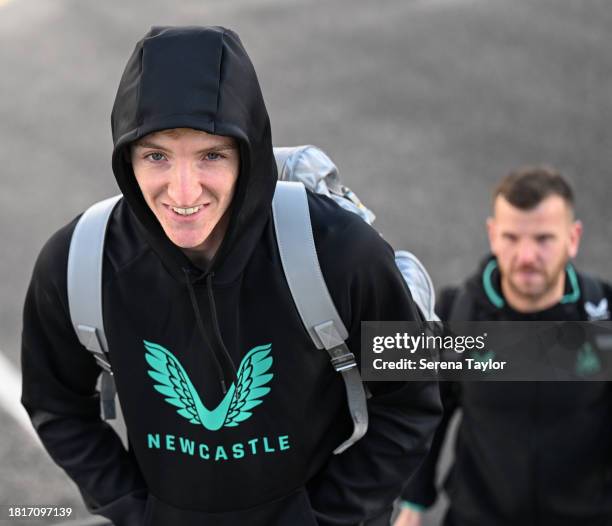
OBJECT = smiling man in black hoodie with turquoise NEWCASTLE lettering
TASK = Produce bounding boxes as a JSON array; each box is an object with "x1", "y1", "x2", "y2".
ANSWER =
[{"x1": 22, "y1": 27, "x2": 441, "y2": 526}]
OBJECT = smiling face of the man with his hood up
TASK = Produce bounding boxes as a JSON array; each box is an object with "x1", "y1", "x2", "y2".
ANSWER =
[{"x1": 131, "y1": 128, "x2": 240, "y2": 261}]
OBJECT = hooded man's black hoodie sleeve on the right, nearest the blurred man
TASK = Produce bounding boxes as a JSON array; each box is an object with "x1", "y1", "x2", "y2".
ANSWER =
[{"x1": 308, "y1": 221, "x2": 441, "y2": 526}]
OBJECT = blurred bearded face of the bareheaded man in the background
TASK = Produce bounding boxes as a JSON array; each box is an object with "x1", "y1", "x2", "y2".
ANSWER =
[{"x1": 487, "y1": 195, "x2": 582, "y2": 312}]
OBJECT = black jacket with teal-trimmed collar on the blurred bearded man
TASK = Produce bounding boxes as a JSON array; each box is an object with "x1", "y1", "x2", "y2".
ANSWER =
[{"x1": 402, "y1": 257, "x2": 612, "y2": 526}]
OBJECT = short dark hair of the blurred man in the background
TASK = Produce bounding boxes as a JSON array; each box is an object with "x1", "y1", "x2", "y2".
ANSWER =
[{"x1": 493, "y1": 166, "x2": 574, "y2": 210}]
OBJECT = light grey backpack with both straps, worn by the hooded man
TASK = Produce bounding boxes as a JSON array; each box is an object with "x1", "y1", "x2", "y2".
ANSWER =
[{"x1": 67, "y1": 146, "x2": 437, "y2": 454}]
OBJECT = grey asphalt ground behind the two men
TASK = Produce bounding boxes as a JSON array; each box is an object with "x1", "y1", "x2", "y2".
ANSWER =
[{"x1": 0, "y1": 0, "x2": 612, "y2": 525}]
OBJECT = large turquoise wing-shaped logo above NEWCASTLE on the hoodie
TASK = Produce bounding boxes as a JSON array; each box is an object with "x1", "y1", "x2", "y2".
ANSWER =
[{"x1": 144, "y1": 341, "x2": 273, "y2": 431}]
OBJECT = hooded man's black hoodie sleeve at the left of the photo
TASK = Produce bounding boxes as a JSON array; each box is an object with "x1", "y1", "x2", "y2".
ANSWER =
[{"x1": 21, "y1": 225, "x2": 146, "y2": 526}]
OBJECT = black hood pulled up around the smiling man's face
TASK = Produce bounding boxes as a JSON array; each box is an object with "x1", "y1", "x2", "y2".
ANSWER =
[{"x1": 111, "y1": 26, "x2": 277, "y2": 282}]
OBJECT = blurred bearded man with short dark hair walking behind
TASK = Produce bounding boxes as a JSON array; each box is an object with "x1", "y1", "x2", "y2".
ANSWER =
[{"x1": 394, "y1": 168, "x2": 612, "y2": 526}]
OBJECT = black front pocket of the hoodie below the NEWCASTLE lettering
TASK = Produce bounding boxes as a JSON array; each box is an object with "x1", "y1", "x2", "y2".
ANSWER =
[{"x1": 144, "y1": 487, "x2": 317, "y2": 526}]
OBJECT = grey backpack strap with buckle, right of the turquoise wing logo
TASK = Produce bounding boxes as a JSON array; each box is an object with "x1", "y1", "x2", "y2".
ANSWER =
[{"x1": 272, "y1": 181, "x2": 368, "y2": 454}]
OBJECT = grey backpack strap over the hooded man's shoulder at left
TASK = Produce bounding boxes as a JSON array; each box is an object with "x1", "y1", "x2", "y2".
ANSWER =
[{"x1": 68, "y1": 195, "x2": 122, "y2": 420}]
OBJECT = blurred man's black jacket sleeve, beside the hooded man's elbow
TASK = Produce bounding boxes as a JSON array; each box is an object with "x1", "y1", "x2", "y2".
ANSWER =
[{"x1": 400, "y1": 288, "x2": 460, "y2": 510}]
